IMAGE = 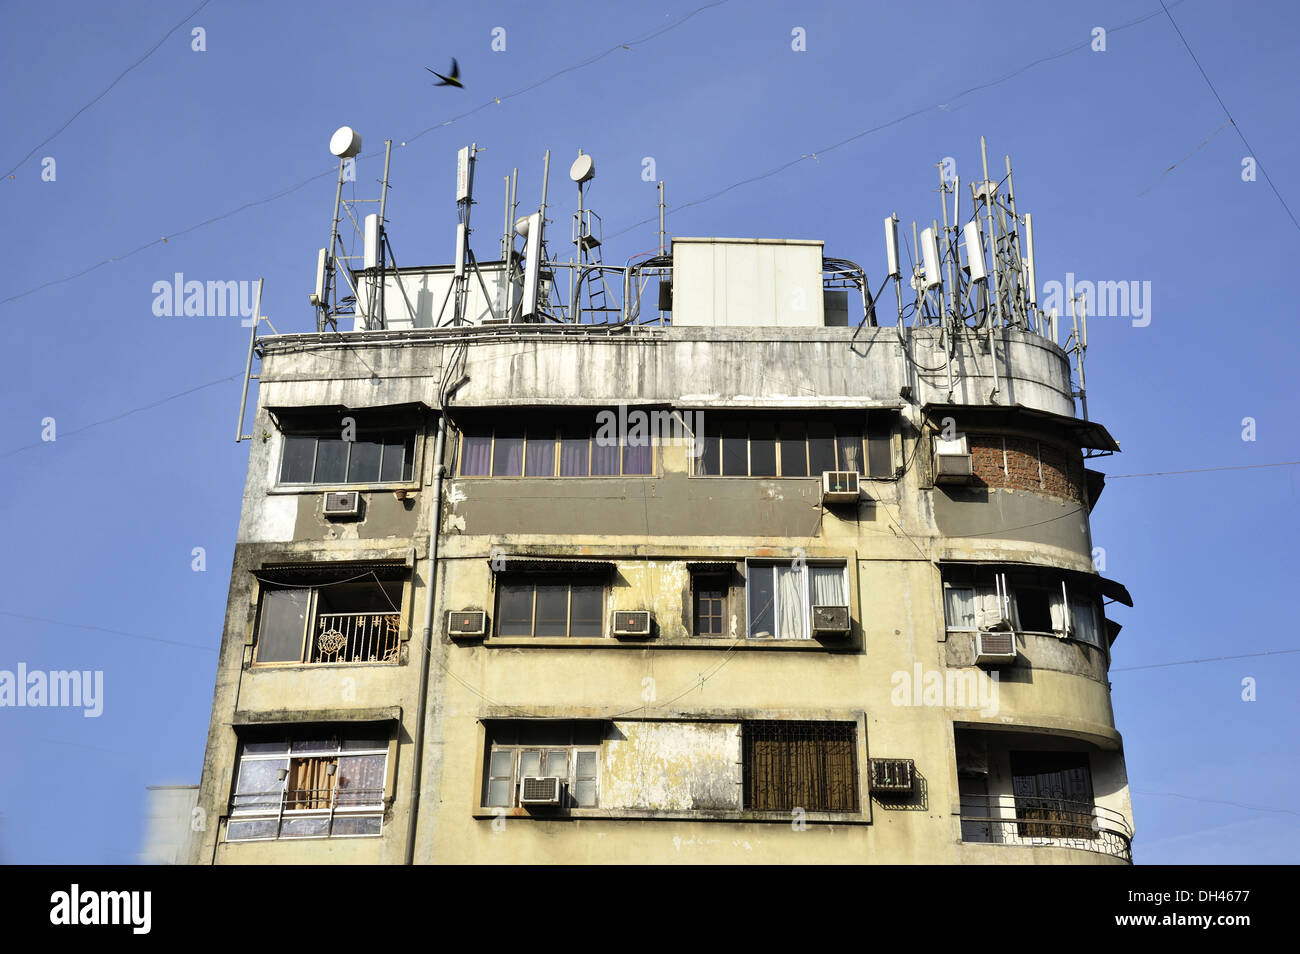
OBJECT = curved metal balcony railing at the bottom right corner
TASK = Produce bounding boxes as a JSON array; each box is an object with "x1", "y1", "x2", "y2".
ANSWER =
[{"x1": 961, "y1": 795, "x2": 1134, "y2": 862}]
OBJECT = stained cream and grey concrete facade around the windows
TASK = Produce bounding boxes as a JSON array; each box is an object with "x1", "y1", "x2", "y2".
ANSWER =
[{"x1": 192, "y1": 237, "x2": 1131, "y2": 863}]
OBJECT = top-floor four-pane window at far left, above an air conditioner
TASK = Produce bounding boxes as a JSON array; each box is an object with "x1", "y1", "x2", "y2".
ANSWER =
[{"x1": 280, "y1": 425, "x2": 415, "y2": 485}]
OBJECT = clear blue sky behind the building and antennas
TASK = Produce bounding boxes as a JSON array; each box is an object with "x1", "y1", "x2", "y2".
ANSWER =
[{"x1": 0, "y1": 0, "x2": 1300, "y2": 863}]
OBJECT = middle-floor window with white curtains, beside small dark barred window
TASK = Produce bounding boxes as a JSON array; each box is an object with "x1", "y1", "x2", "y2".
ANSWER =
[{"x1": 745, "y1": 561, "x2": 849, "y2": 639}]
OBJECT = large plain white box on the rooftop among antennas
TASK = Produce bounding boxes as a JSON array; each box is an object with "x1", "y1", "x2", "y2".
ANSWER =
[{"x1": 672, "y1": 238, "x2": 826, "y2": 328}]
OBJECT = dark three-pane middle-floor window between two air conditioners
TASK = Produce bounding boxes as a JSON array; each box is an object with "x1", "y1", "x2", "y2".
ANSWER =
[{"x1": 497, "y1": 577, "x2": 605, "y2": 637}]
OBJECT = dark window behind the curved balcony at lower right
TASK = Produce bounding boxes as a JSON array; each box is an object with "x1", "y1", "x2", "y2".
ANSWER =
[{"x1": 1011, "y1": 753, "x2": 1097, "y2": 838}]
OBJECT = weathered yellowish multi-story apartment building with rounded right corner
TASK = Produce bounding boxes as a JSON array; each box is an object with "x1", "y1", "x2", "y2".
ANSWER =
[{"x1": 194, "y1": 136, "x2": 1132, "y2": 863}]
